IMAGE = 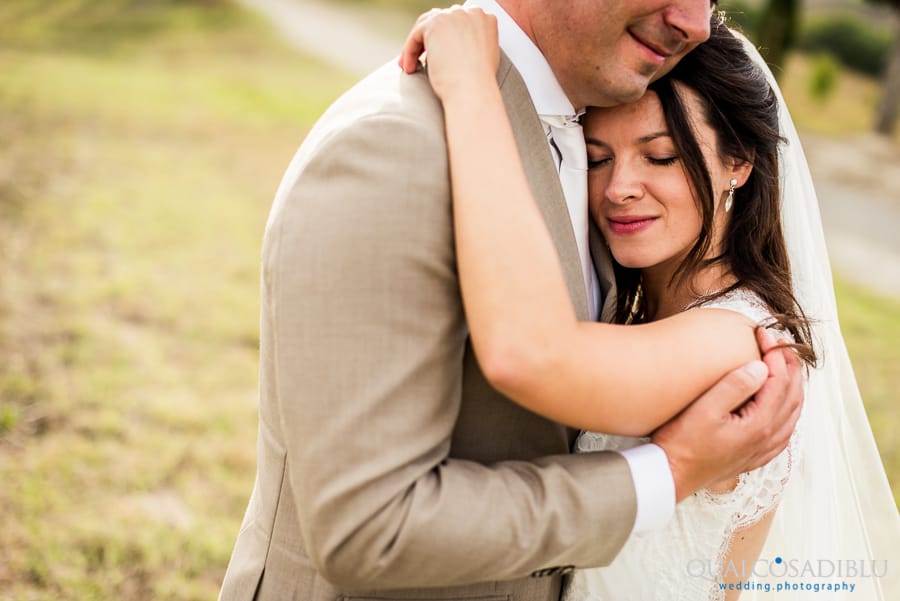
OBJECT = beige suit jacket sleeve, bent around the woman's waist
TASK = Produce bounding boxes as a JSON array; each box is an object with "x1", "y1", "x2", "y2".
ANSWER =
[{"x1": 263, "y1": 105, "x2": 635, "y2": 588}]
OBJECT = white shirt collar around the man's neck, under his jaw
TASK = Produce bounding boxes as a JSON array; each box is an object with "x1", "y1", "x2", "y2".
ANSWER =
[{"x1": 465, "y1": 0, "x2": 584, "y2": 116}]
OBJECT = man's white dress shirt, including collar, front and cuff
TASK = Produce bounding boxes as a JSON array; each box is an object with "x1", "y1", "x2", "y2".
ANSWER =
[{"x1": 466, "y1": 0, "x2": 675, "y2": 532}]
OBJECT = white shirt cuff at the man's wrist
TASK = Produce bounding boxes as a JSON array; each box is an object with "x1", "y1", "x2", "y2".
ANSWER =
[{"x1": 620, "y1": 443, "x2": 675, "y2": 534}]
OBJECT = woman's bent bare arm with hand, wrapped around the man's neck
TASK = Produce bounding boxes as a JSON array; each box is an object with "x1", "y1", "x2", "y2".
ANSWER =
[{"x1": 406, "y1": 11, "x2": 759, "y2": 435}]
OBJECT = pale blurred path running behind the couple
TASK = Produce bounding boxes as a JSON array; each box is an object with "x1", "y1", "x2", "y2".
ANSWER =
[{"x1": 239, "y1": 0, "x2": 900, "y2": 298}]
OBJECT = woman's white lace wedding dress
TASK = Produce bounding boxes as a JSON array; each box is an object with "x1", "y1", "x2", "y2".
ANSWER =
[{"x1": 563, "y1": 290, "x2": 802, "y2": 601}]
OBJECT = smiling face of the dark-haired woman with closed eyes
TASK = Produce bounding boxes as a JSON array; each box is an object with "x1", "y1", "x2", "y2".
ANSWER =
[{"x1": 584, "y1": 87, "x2": 743, "y2": 272}]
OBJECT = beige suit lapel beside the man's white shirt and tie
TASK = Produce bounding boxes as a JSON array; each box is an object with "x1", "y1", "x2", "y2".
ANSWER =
[{"x1": 497, "y1": 55, "x2": 589, "y2": 320}]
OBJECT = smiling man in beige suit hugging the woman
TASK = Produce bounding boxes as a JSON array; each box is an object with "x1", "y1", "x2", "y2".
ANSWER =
[{"x1": 220, "y1": 0, "x2": 800, "y2": 601}]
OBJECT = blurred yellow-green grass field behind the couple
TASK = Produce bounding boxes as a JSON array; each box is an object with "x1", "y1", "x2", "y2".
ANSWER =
[{"x1": 0, "y1": 0, "x2": 900, "y2": 600}]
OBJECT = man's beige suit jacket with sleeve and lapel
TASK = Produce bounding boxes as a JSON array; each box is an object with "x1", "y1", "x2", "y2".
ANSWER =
[{"x1": 220, "y1": 57, "x2": 636, "y2": 601}]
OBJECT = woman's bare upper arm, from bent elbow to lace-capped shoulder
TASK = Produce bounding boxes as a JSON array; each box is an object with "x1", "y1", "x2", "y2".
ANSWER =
[{"x1": 532, "y1": 309, "x2": 759, "y2": 436}]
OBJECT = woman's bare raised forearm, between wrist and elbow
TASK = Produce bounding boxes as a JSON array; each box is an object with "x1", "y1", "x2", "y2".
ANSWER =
[{"x1": 444, "y1": 80, "x2": 576, "y2": 385}]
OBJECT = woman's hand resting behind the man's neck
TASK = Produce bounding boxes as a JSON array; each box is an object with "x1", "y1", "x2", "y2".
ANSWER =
[{"x1": 398, "y1": 6, "x2": 500, "y2": 100}]
